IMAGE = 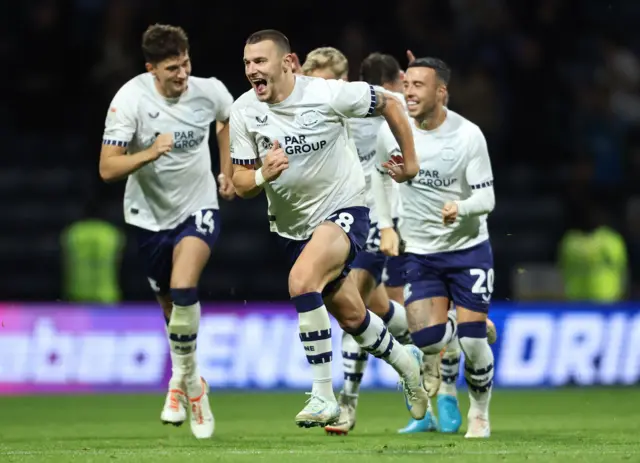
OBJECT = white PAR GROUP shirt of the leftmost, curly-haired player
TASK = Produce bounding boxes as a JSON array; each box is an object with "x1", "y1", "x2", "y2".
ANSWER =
[{"x1": 103, "y1": 73, "x2": 233, "y2": 231}]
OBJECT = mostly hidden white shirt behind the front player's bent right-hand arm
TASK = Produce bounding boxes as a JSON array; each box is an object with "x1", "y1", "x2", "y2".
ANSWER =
[{"x1": 349, "y1": 85, "x2": 408, "y2": 224}]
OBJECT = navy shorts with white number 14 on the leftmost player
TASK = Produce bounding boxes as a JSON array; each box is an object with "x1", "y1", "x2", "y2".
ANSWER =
[{"x1": 133, "y1": 209, "x2": 220, "y2": 294}]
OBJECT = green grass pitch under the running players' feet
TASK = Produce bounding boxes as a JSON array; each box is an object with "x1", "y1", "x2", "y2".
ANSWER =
[{"x1": 0, "y1": 388, "x2": 640, "y2": 463}]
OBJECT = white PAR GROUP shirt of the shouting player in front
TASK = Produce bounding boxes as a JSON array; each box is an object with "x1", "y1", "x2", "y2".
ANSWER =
[{"x1": 230, "y1": 76, "x2": 376, "y2": 240}]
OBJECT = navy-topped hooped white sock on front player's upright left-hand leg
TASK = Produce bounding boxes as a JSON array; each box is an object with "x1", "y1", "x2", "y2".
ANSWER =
[{"x1": 292, "y1": 293, "x2": 336, "y2": 400}]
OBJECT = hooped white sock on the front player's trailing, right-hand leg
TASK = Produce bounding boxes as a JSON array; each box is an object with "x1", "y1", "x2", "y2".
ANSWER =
[{"x1": 351, "y1": 310, "x2": 415, "y2": 376}]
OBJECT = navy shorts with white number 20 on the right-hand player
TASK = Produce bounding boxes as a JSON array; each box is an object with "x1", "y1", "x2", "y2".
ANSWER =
[{"x1": 401, "y1": 240, "x2": 495, "y2": 313}]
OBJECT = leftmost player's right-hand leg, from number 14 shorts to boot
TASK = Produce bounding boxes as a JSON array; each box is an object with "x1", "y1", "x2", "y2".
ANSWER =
[{"x1": 168, "y1": 210, "x2": 219, "y2": 439}]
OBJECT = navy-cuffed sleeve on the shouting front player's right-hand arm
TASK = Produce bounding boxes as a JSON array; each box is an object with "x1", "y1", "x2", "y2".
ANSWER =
[{"x1": 327, "y1": 80, "x2": 376, "y2": 118}]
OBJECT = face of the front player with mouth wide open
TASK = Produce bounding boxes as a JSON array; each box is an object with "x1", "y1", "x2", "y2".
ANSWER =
[{"x1": 244, "y1": 40, "x2": 292, "y2": 103}]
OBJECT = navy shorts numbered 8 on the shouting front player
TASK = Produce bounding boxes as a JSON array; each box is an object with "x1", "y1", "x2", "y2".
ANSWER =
[{"x1": 278, "y1": 206, "x2": 369, "y2": 295}]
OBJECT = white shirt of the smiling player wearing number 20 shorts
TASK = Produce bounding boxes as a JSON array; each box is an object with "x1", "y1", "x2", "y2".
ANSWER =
[{"x1": 378, "y1": 110, "x2": 493, "y2": 254}]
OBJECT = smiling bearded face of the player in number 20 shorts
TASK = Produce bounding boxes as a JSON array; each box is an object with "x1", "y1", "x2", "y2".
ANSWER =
[{"x1": 404, "y1": 67, "x2": 447, "y2": 119}]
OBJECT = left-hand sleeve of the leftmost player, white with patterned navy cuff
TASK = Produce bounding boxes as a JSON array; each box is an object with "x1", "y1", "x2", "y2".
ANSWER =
[{"x1": 102, "y1": 88, "x2": 138, "y2": 147}]
